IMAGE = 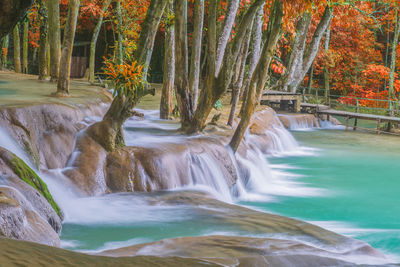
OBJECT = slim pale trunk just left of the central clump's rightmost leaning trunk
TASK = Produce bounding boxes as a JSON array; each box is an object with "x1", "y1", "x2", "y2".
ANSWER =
[{"x1": 239, "y1": 5, "x2": 264, "y2": 116}]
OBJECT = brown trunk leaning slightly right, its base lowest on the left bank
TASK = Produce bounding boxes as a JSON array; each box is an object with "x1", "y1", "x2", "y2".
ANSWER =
[{"x1": 57, "y1": 0, "x2": 80, "y2": 96}]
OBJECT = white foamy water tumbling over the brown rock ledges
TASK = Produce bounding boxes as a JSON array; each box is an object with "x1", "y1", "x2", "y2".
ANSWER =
[{"x1": 0, "y1": 110, "x2": 326, "y2": 216}]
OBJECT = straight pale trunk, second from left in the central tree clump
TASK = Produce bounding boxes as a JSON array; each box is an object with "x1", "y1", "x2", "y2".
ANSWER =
[{"x1": 189, "y1": 0, "x2": 204, "y2": 109}]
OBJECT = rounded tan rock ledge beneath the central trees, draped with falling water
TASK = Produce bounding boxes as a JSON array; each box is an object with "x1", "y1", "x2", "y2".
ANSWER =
[{"x1": 64, "y1": 108, "x2": 282, "y2": 196}]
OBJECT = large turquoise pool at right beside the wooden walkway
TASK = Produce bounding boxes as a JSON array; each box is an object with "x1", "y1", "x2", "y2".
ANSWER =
[{"x1": 242, "y1": 130, "x2": 400, "y2": 259}]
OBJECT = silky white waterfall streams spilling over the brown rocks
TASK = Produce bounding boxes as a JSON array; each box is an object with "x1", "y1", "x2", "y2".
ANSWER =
[{"x1": 0, "y1": 110, "x2": 319, "y2": 222}]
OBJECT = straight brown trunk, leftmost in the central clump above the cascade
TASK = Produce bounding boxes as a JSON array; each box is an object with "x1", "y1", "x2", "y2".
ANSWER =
[{"x1": 175, "y1": 0, "x2": 193, "y2": 130}]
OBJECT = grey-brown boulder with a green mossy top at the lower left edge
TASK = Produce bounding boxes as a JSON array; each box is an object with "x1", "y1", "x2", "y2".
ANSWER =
[{"x1": 0, "y1": 147, "x2": 62, "y2": 246}]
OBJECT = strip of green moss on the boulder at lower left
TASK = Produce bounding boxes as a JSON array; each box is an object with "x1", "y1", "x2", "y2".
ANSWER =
[{"x1": 9, "y1": 155, "x2": 62, "y2": 218}]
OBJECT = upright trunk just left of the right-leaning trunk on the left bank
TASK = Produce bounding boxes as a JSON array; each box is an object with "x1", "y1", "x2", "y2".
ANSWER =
[{"x1": 46, "y1": 0, "x2": 61, "y2": 82}]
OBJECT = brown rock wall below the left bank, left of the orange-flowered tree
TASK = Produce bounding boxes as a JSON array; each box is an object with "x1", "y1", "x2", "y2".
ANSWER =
[{"x1": 0, "y1": 103, "x2": 105, "y2": 169}]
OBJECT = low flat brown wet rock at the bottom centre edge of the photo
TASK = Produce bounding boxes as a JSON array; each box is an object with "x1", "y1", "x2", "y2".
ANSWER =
[{"x1": 101, "y1": 236, "x2": 360, "y2": 267}]
